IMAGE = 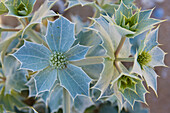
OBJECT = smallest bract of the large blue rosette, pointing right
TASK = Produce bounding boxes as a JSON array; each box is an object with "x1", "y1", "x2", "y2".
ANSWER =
[{"x1": 65, "y1": 44, "x2": 89, "y2": 61}]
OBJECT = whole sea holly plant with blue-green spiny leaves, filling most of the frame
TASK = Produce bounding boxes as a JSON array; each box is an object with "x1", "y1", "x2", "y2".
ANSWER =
[{"x1": 0, "y1": 0, "x2": 166, "y2": 113}]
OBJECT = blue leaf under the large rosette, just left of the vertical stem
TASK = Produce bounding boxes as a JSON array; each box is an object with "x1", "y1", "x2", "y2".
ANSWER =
[{"x1": 47, "y1": 84, "x2": 63, "y2": 113}]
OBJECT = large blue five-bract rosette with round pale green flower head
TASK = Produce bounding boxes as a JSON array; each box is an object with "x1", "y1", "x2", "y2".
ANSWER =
[{"x1": 14, "y1": 16, "x2": 91, "y2": 98}]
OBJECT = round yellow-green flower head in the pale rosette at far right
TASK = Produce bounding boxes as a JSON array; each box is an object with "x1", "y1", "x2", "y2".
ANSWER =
[{"x1": 137, "y1": 51, "x2": 152, "y2": 67}]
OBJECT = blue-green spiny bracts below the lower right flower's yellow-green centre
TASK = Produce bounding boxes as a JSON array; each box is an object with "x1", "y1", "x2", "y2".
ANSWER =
[{"x1": 121, "y1": 80, "x2": 147, "y2": 107}]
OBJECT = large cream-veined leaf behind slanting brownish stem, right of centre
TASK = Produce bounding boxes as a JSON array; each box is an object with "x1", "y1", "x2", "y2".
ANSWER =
[{"x1": 91, "y1": 16, "x2": 130, "y2": 59}]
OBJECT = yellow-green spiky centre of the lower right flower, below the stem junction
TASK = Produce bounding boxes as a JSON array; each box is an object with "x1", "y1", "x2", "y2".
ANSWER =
[{"x1": 118, "y1": 75, "x2": 136, "y2": 92}]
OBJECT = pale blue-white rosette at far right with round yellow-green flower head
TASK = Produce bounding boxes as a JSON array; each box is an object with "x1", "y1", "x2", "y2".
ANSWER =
[{"x1": 131, "y1": 27, "x2": 166, "y2": 94}]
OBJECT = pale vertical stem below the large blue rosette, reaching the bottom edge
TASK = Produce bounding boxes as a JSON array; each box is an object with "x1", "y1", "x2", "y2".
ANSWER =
[{"x1": 63, "y1": 88, "x2": 70, "y2": 113}]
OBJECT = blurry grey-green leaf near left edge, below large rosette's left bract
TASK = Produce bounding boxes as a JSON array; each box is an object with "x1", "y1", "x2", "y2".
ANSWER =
[{"x1": 4, "y1": 56, "x2": 28, "y2": 94}]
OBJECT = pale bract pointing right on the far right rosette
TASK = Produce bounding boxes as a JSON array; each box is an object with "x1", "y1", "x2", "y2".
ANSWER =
[{"x1": 148, "y1": 47, "x2": 166, "y2": 67}]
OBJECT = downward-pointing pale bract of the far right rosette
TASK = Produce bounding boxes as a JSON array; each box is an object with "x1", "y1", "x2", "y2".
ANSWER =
[{"x1": 142, "y1": 66, "x2": 158, "y2": 94}]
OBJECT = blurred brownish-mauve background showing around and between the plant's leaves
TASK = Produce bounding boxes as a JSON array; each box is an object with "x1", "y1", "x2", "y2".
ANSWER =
[{"x1": 0, "y1": 0, "x2": 170, "y2": 113}]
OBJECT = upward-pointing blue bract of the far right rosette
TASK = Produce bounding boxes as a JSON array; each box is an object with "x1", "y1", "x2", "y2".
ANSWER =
[{"x1": 144, "y1": 27, "x2": 159, "y2": 51}]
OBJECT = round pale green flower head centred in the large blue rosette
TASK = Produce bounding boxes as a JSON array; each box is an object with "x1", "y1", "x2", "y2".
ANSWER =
[{"x1": 50, "y1": 52, "x2": 67, "y2": 69}]
